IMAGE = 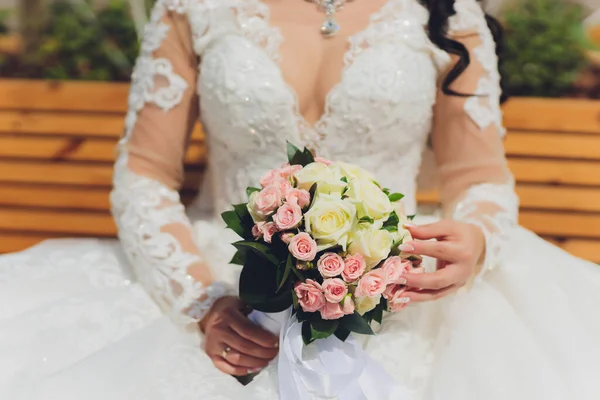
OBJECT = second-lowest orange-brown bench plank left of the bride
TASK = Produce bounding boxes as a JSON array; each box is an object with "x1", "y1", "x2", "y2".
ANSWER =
[{"x1": 0, "y1": 207, "x2": 116, "y2": 236}]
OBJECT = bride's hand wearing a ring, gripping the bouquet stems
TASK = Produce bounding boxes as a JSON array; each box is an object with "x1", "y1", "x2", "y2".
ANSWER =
[{"x1": 200, "y1": 297, "x2": 279, "y2": 376}]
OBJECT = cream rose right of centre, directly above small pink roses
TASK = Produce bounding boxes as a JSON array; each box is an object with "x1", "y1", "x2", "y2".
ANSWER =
[{"x1": 348, "y1": 229, "x2": 394, "y2": 269}]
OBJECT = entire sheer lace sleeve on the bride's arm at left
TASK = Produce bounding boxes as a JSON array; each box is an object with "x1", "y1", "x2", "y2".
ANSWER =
[{"x1": 111, "y1": 0, "x2": 226, "y2": 323}]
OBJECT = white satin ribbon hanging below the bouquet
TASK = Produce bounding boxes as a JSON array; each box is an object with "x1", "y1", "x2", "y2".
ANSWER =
[{"x1": 250, "y1": 309, "x2": 409, "y2": 400}]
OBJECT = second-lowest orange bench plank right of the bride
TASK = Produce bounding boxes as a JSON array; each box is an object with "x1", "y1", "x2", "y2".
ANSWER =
[{"x1": 519, "y1": 210, "x2": 600, "y2": 239}]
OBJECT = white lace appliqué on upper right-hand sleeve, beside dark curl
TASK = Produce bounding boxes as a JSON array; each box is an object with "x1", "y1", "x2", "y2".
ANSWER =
[{"x1": 450, "y1": 0, "x2": 506, "y2": 136}]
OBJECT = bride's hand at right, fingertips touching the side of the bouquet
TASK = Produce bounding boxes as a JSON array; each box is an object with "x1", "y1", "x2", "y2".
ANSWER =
[{"x1": 401, "y1": 220, "x2": 485, "y2": 302}]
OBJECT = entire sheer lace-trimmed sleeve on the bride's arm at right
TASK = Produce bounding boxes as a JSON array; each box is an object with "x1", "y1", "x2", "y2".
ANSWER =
[{"x1": 432, "y1": 0, "x2": 519, "y2": 280}]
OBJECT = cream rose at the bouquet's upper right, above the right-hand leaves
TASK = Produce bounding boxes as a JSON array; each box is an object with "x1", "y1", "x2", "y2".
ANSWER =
[{"x1": 346, "y1": 179, "x2": 394, "y2": 220}]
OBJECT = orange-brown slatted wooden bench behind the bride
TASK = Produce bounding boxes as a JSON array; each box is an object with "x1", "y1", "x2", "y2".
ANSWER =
[{"x1": 0, "y1": 80, "x2": 600, "y2": 263}]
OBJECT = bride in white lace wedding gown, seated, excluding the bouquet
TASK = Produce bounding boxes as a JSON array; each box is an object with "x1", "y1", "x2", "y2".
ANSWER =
[{"x1": 0, "y1": 0, "x2": 600, "y2": 400}]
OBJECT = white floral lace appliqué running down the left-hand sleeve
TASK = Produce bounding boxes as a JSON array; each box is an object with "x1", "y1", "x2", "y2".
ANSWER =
[{"x1": 111, "y1": 0, "x2": 227, "y2": 323}]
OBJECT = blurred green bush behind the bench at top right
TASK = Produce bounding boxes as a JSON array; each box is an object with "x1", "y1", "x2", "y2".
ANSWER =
[{"x1": 502, "y1": 0, "x2": 588, "y2": 97}]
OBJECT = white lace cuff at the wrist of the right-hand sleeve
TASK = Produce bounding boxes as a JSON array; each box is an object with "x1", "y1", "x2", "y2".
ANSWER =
[{"x1": 453, "y1": 180, "x2": 519, "y2": 277}]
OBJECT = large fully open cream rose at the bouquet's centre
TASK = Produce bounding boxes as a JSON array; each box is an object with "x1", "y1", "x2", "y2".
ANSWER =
[{"x1": 304, "y1": 195, "x2": 356, "y2": 251}]
